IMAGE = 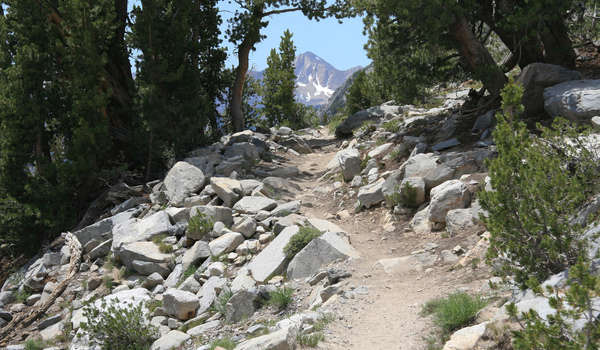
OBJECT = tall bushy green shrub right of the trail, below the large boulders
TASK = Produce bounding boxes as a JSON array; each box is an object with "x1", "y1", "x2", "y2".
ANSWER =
[{"x1": 478, "y1": 82, "x2": 599, "y2": 286}]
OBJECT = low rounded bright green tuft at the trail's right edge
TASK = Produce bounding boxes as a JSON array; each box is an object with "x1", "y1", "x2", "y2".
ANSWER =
[{"x1": 421, "y1": 292, "x2": 486, "y2": 332}]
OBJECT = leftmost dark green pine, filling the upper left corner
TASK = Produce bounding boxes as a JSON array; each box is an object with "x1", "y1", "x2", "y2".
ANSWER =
[{"x1": 0, "y1": 0, "x2": 125, "y2": 252}]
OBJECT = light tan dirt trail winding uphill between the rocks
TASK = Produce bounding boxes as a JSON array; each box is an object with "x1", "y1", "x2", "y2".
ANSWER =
[{"x1": 274, "y1": 147, "x2": 490, "y2": 350}]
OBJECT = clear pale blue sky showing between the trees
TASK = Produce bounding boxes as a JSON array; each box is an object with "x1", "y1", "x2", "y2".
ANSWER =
[{"x1": 129, "y1": 0, "x2": 370, "y2": 71}]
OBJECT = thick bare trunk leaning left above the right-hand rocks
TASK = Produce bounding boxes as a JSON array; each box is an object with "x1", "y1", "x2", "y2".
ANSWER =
[{"x1": 452, "y1": 16, "x2": 508, "y2": 95}]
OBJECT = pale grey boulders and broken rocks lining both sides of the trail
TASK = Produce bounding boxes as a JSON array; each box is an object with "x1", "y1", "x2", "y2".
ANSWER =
[{"x1": 0, "y1": 61, "x2": 600, "y2": 350}]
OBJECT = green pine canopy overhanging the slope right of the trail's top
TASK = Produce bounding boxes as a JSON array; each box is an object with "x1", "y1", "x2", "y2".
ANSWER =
[{"x1": 354, "y1": 0, "x2": 596, "y2": 103}]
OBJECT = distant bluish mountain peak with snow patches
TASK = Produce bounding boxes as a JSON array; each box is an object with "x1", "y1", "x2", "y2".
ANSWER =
[{"x1": 250, "y1": 51, "x2": 363, "y2": 107}]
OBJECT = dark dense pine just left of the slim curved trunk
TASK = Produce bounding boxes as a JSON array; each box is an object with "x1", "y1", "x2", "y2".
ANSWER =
[{"x1": 131, "y1": 0, "x2": 226, "y2": 178}]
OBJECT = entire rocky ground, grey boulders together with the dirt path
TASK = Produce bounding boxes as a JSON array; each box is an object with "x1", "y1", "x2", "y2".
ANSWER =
[{"x1": 0, "y1": 60, "x2": 600, "y2": 350}]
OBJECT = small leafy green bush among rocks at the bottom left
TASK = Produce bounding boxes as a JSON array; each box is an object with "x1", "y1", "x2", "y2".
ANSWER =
[{"x1": 81, "y1": 298, "x2": 159, "y2": 350}]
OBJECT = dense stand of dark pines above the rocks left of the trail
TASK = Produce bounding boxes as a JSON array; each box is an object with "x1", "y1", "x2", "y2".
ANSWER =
[{"x1": 0, "y1": 0, "x2": 226, "y2": 256}]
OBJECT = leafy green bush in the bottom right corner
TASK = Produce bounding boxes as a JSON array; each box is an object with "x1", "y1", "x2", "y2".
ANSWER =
[{"x1": 506, "y1": 259, "x2": 600, "y2": 350}]
